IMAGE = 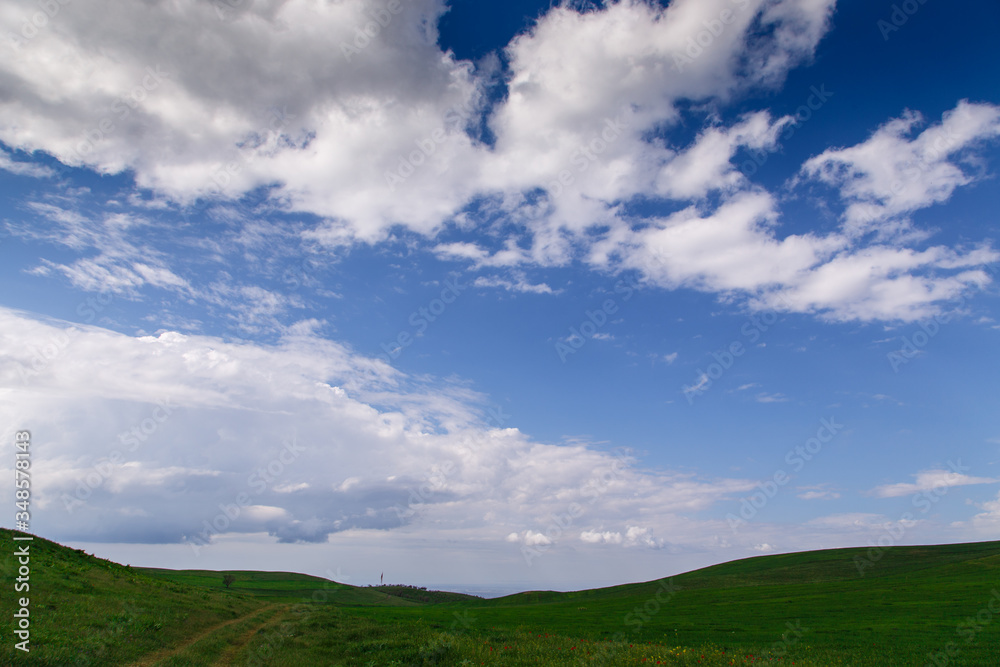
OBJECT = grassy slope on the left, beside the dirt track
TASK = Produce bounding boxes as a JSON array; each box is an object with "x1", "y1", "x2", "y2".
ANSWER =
[{"x1": 0, "y1": 528, "x2": 430, "y2": 667}]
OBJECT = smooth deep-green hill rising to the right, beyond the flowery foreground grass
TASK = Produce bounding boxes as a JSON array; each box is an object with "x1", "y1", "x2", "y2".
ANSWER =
[{"x1": 342, "y1": 542, "x2": 1000, "y2": 666}]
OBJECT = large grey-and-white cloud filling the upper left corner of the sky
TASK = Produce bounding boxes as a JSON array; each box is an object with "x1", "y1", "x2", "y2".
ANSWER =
[{"x1": 0, "y1": 0, "x2": 479, "y2": 243}]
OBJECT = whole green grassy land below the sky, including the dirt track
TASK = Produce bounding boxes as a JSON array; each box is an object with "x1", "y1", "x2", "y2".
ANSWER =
[{"x1": 0, "y1": 529, "x2": 1000, "y2": 667}]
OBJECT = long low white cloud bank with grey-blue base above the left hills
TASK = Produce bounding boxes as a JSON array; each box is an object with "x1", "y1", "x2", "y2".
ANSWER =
[{"x1": 0, "y1": 310, "x2": 753, "y2": 549}]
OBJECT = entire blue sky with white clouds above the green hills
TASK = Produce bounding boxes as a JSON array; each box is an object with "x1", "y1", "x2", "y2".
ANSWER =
[{"x1": 0, "y1": 0, "x2": 1000, "y2": 592}]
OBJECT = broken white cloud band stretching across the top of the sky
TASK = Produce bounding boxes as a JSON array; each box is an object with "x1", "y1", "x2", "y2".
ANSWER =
[{"x1": 0, "y1": 0, "x2": 1000, "y2": 327}]
